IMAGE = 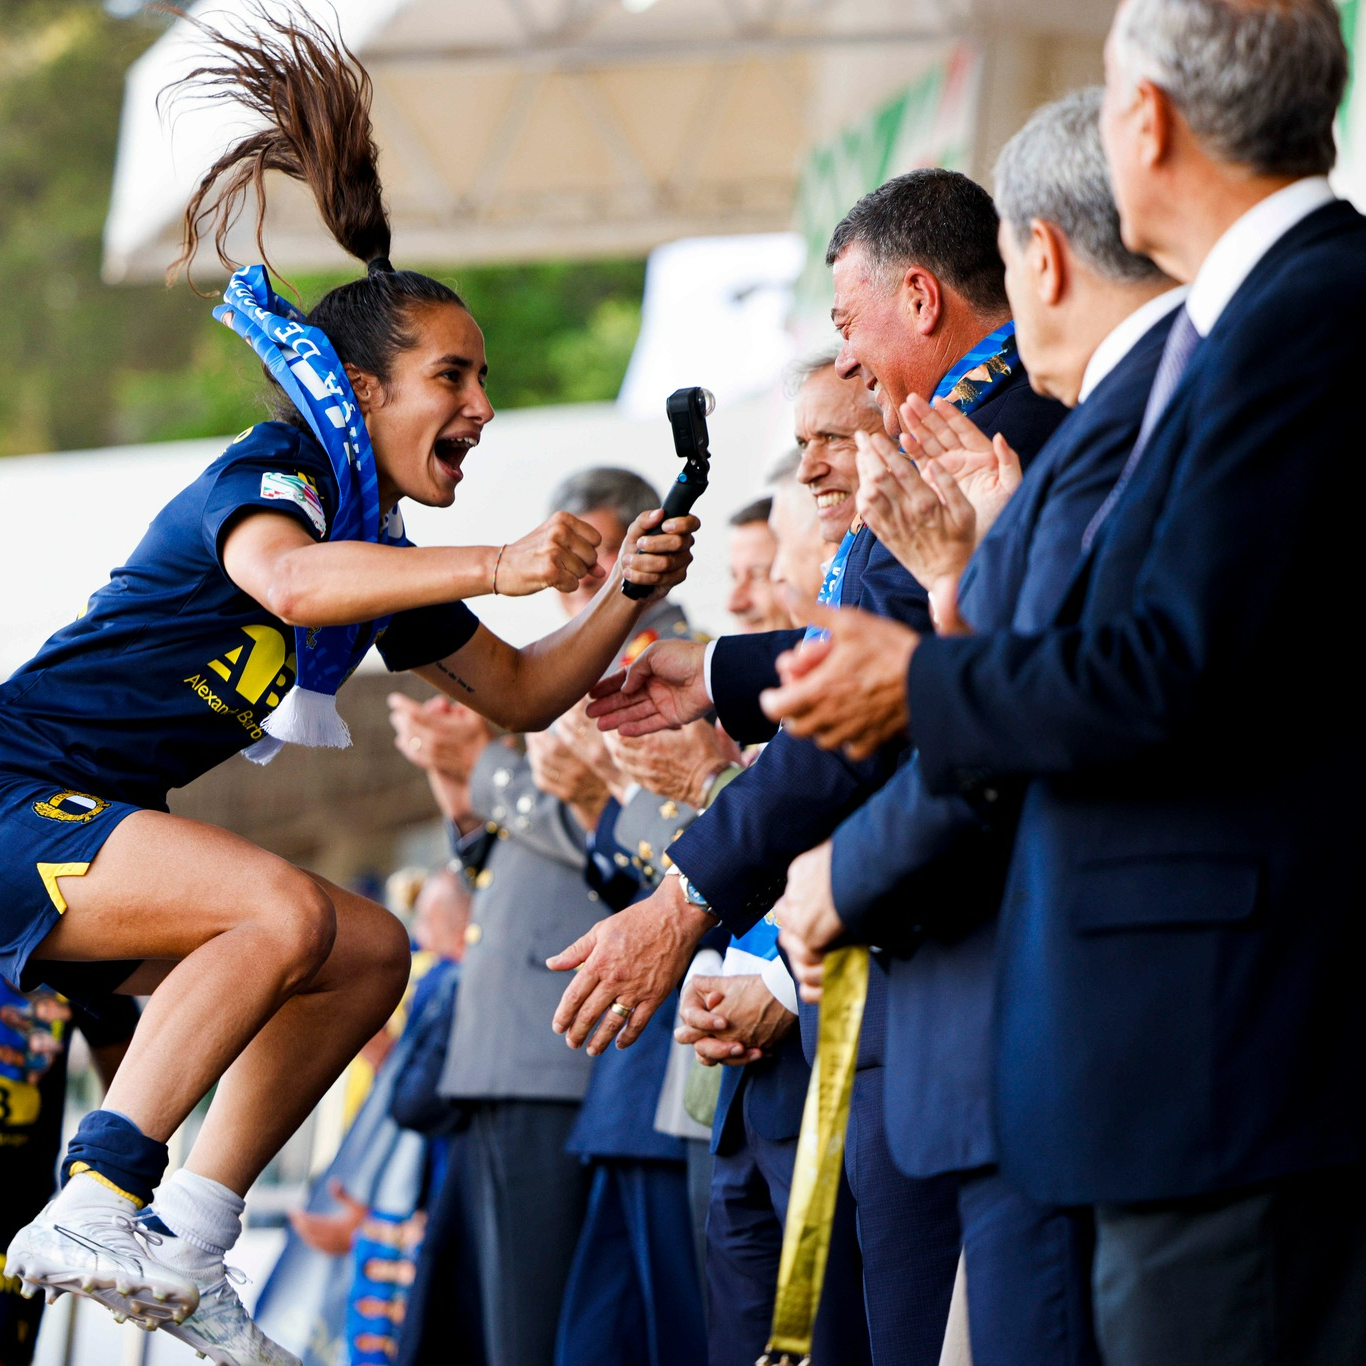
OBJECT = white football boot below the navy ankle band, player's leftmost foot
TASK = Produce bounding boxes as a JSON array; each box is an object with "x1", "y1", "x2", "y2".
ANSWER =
[{"x1": 5, "y1": 1205, "x2": 199, "y2": 1329}]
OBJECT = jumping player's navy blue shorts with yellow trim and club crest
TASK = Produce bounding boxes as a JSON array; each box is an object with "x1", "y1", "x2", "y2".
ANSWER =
[{"x1": 0, "y1": 773, "x2": 142, "y2": 1000}]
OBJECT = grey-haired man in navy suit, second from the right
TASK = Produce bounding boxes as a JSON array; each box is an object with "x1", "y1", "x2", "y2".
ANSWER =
[{"x1": 777, "y1": 90, "x2": 1184, "y2": 1366}]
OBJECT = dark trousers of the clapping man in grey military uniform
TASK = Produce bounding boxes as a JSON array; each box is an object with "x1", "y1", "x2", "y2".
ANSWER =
[{"x1": 464, "y1": 1101, "x2": 589, "y2": 1366}]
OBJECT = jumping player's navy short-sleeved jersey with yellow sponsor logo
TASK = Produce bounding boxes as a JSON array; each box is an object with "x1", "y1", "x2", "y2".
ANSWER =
[{"x1": 0, "y1": 422, "x2": 478, "y2": 807}]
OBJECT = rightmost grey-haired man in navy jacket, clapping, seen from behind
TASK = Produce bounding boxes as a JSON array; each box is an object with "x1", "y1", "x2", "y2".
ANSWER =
[{"x1": 766, "y1": 0, "x2": 1366, "y2": 1366}]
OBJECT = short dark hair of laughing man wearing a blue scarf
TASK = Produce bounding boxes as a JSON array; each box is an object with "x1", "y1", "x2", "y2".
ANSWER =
[{"x1": 825, "y1": 167, "x2": 1009, "y2": 313}]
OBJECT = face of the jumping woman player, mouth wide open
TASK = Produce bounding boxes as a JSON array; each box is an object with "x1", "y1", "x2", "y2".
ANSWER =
[{"x1": 347, "y1": 303, "x2": 493, "y2": 510}]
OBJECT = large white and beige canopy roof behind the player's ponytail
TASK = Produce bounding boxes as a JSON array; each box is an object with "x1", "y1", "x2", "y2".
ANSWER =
[{"x1": 105, "y1": 0, "x2": 1112, "y2": 281}]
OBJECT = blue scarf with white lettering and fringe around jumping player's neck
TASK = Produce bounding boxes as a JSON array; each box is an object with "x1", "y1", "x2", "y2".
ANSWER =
[{"x1": 213, "y1": 265, "x2": 403, "y2": 764}]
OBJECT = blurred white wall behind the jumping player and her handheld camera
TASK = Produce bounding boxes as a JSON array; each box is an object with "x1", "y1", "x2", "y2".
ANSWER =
[{"x1": 0, "y1": 393, "x2": 791, "y2": 678}]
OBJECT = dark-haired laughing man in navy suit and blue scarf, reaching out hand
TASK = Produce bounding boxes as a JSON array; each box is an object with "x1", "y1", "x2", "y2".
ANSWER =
[{"x1": 552, "y1": 171, "x2": 1063, "y2": 1363}]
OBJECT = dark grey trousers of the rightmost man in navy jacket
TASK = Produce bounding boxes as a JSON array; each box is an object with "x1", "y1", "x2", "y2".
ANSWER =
[{"x1": 1094, "y1": 1164, "x2": 1366, "y2": 1366}]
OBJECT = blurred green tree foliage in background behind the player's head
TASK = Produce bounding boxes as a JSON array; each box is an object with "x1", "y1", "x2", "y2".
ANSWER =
[{"x1": 0, "y1": 0, "x2": 645, "y2": 455}]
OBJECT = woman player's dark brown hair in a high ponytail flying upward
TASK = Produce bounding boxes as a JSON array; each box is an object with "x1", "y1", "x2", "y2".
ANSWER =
[{"x1": 168, "y1": 4, "x2": 464, "y2": 398}]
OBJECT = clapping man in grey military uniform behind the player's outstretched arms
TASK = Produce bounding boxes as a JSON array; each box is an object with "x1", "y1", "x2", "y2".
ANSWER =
[{"x1": 391, "y1": 469, "x2": 686, "y2": 1366}]
